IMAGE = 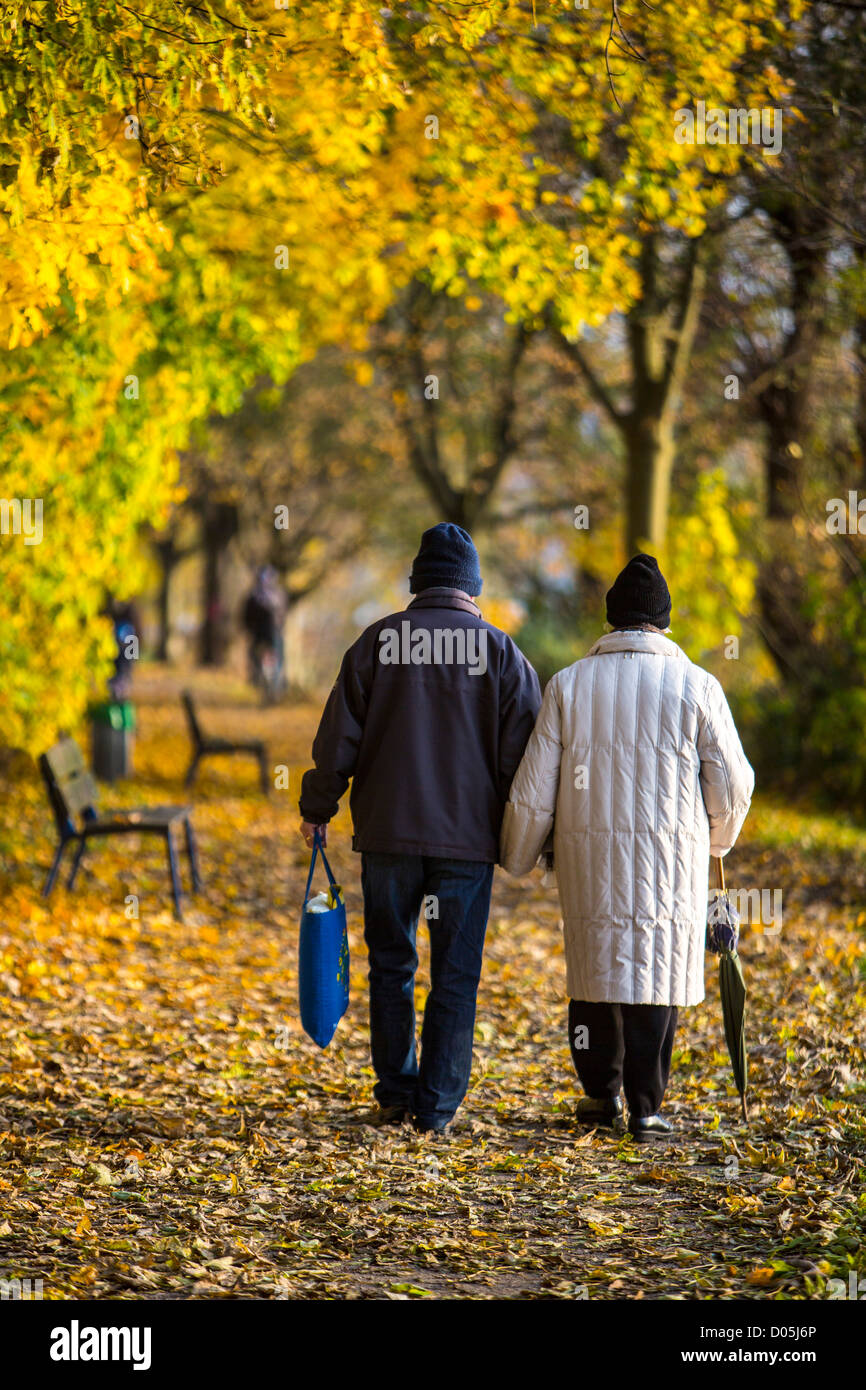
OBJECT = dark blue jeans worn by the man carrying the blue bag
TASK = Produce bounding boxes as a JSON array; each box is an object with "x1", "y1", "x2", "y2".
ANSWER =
[{"x1": 361, "y1": 853, "x2": 493, "y2": 1127}]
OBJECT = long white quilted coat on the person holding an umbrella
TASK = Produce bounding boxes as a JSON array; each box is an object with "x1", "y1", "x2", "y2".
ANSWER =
[{"x1": 500, "y1": 628, "x2": 755, "y2": 1005}]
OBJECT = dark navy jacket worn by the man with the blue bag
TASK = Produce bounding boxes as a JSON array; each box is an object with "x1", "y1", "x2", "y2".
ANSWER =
[{"x1": 299, "y1": 589, "x2": 541, "y2": 863}]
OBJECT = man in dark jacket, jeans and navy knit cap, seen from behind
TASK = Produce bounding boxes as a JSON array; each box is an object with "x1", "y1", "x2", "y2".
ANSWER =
[{"x1": 300, "y1": 523, "x2": 541, "y2": 1131}]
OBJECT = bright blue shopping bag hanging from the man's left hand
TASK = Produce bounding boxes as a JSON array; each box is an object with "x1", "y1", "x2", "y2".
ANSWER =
[{"x1": 297, "y1": 830, "x2": 349, "y2": 1047}]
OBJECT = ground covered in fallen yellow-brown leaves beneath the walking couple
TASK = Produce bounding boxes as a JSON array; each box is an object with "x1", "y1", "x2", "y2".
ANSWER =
[{"x1": 0, "y1": 669, "x2": 866, "y2": 1300}]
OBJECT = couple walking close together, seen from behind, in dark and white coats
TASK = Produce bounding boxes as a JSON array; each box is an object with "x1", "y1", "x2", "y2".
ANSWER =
[{"x1": 300, "y1": 523, "x2": 753, "y2": 1140}]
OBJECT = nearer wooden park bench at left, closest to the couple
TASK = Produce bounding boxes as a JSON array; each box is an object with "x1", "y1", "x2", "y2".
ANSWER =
[{"x1": 39, "y1": 738, "x2": 202, "y2": 922}]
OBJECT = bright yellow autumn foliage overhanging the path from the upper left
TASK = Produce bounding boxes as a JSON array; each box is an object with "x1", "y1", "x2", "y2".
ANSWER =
[{"x1": 0, "y1": 0, "x2": 792, "y2": 744}]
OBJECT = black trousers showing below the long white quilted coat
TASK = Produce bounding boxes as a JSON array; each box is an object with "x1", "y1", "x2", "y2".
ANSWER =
[{"x1": 569, "y1": 999, "x2": 677, "y2": 1116}]
